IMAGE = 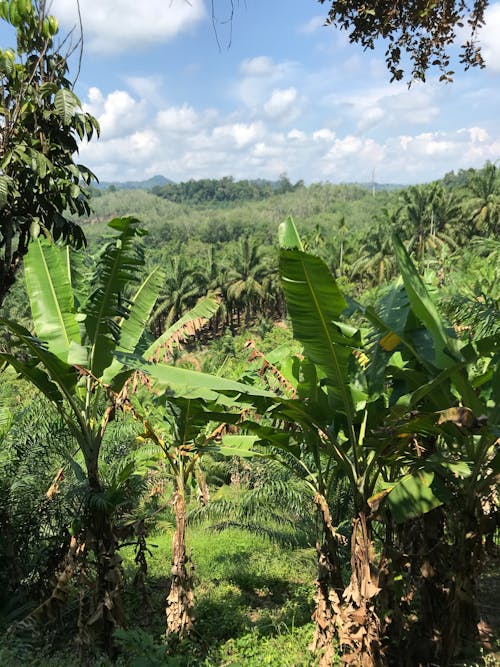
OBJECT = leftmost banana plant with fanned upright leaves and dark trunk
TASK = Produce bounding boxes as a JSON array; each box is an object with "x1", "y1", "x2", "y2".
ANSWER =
[{"x1": 0, "y1": 218, "x2": 168, "y2": 649}]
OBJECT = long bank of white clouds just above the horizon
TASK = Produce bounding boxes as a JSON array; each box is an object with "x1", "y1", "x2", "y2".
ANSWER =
[{"x1": 77, "y1": 82, "x2": 500, "y2": 183}]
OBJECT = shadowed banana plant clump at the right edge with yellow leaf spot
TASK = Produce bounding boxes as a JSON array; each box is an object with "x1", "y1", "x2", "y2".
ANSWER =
[{"x1": 364, "y1": 237, "x2": 500, "y2": 665}]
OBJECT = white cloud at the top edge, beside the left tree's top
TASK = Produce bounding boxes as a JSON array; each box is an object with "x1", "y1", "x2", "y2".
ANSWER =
[{"x1": 52, "y1": 0, "x2": 205, "y2": 53}]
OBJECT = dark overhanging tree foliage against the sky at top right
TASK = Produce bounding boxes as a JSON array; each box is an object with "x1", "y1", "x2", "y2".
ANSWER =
[{"x1": 319, "y1": 0, "x2": 489, "y2": 81}]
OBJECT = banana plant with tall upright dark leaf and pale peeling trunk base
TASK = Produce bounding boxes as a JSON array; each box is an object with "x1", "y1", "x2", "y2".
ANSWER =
[{"x1": 275, "y1": 218, "x2": 394, "y2": 665}]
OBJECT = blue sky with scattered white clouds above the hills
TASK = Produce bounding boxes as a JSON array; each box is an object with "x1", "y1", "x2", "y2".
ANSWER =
[{"x1": 40, "y1": 0, "x2": 500, "y2": 184}]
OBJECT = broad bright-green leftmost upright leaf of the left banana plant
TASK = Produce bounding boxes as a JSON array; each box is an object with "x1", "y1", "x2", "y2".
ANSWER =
[{"x1": 24, "y1": 239, "x2": 80, "y2": 362}]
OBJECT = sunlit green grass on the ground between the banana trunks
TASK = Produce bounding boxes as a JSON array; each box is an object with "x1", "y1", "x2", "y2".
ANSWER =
[{"x1": 113, "y1": 528, "x2": 316, "y2": 667}]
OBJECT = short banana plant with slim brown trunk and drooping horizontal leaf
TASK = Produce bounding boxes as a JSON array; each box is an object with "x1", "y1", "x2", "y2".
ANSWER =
[{"x1": 116, "y1": 344, "x2": 275, "y2": 638}]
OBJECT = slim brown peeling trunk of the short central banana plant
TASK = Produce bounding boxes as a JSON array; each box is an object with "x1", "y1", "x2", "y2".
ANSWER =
[{"x1": 166, "y1": 474, "x2": 194, "y2": 637}]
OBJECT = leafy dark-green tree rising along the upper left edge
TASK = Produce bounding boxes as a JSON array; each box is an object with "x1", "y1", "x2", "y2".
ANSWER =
[{"x1": 0, "y1": 0, "x2": 99, "y2": 305}]
